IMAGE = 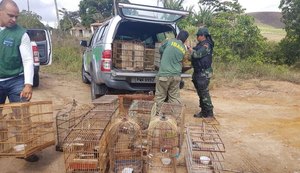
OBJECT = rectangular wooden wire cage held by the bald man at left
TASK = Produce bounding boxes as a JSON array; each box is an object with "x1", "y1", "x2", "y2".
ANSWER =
[{"x1": 0, "y1": 101, "x2": 55, "y2": 158}]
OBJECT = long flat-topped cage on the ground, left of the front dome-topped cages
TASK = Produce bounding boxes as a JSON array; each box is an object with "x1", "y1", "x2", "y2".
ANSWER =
[{"x1": 63, "y1": 111, "x2": 114, "y2": 172}]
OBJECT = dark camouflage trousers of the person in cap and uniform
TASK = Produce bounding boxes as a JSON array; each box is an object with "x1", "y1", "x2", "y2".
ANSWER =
[{"x1": 192, "y1": 68, "x2": 213, "y2": 111}]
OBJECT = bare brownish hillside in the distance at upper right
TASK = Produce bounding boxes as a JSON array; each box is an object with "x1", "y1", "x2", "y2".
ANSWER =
[{"x1": 247, "y1": 12, "x2": 284, "y2": 28}]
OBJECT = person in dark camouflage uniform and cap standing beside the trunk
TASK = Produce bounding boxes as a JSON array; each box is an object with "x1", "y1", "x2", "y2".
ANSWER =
[{"x1": 189, "y1": 28, "x2": 214, "y2": 118}]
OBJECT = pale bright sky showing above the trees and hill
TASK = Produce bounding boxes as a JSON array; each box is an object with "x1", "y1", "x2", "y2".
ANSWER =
[{"x1": 14, "y1": 0, "x2": 280, "y2": 27}]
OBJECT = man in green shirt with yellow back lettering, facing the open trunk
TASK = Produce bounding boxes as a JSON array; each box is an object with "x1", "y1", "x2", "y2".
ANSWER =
[{"x1": 154, "y1": 30, "x2": 189, "y2": 115}]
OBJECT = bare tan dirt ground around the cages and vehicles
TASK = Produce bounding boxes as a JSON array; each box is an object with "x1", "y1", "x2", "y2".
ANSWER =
[{"x1": 0, "y1": 74, "x2": 300, "y2": 173}]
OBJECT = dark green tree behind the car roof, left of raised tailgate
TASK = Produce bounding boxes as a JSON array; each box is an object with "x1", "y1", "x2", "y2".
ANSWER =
[{"x1": 79, "y1": 0, "x2": 128, "y2": 27}]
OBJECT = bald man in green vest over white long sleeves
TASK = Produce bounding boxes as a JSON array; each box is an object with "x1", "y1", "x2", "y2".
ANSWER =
[{"x1": 0, "y1": 0, "x2": 34, "y2": 104}]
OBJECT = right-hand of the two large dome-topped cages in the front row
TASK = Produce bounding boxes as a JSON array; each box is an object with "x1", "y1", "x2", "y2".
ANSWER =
[{"x1": 147, "y1": 116, "x2": 179, "y2": 173}]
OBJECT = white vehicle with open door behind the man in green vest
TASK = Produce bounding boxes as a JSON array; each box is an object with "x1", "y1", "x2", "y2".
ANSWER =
[{"x1": 27, "y1": 29, "x2": 52, "y2": 87}]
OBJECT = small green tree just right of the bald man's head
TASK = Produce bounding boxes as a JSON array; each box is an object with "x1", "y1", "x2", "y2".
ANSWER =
[{"x1": 17, "y1": 10, "x2": 45, "y2": 28}]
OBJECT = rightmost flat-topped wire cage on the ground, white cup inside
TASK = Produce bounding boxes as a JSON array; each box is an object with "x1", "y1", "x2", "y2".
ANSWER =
[{"x1": 185, "y1": 122, "x2": 225, "y2": 173}]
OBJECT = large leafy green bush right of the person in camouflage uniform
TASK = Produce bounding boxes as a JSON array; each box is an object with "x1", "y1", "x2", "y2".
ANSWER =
[{"x1": 210, "y1": 12, "x2": 266, "y2": 63}]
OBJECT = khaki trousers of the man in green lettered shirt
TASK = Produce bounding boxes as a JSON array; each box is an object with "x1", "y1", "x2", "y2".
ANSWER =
[{"x1": 154, "y1": 76, "x2": 181, "y2": 114}]
